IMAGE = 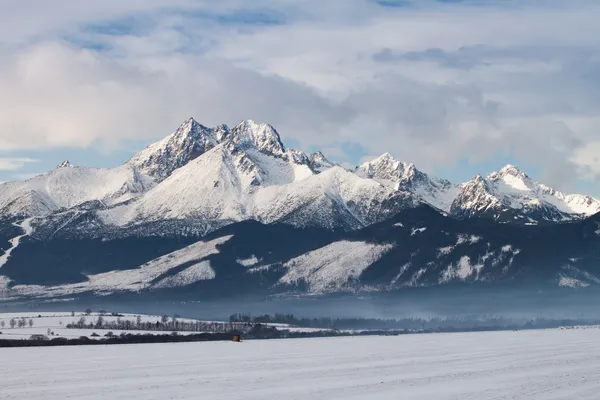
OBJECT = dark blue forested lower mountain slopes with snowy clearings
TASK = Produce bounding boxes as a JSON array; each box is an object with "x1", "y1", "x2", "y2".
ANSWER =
[{"x1": 0, "y1": 205, "x2": 600, "y2": 298}]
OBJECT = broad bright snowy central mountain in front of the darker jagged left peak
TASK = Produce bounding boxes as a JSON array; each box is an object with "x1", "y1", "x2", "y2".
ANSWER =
[{"x1": 98, "y1": 121, "x2": 413, "y2": 232}]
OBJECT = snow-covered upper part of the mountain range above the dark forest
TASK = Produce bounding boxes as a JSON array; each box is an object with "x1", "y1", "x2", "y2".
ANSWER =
[{"x1": 0, "y1": 118, "x2": 600, "y2": 241}]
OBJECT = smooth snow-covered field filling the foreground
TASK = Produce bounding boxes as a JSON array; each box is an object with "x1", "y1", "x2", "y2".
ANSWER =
[{"x1": 0, "y1": 329, "x2": 600, "y2": 400}]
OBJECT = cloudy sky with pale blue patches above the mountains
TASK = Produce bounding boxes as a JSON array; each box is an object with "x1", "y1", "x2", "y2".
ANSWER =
[{"x1": 0, "y1": 0, "x2": 600, "y2": 196}]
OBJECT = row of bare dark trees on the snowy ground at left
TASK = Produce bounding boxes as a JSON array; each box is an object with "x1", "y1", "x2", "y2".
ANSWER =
[{"x1": 66, "y1": 315, "x2": 256, "y2": 333}]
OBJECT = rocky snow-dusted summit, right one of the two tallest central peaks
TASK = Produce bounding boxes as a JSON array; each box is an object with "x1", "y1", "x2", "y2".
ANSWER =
[{"x1": 231, "y1": 119, "x2": 285, "y2": 155}]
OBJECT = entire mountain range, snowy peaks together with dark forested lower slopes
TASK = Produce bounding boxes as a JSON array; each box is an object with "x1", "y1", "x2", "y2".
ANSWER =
[{"x1": 0, "y1": 118, "x2": 600, "y2": 298}]
